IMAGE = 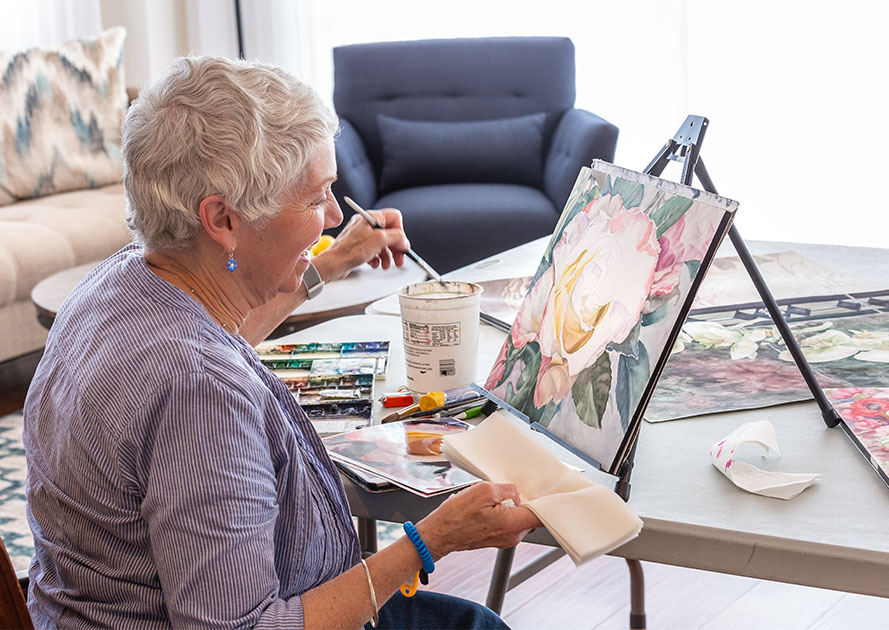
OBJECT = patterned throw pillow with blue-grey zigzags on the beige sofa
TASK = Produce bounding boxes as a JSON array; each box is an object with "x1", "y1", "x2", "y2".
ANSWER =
[{"x1": 0, "y1": 27, "x2": 127, "y2": 205}]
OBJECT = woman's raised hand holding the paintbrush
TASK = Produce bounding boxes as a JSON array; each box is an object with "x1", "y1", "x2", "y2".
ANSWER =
[{"x1": 313, "y1": 208, "x2": 410, "y2": 282}]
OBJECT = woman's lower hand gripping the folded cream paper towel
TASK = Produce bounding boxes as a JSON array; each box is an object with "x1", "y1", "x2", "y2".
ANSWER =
[{"x1": 417, "y1": 481, "x2": 542, "y2": 560}]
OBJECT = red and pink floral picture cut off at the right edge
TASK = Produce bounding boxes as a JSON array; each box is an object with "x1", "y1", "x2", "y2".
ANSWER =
[{"x1": 824, "y1": 387, "x2": 889, "y2": 483}]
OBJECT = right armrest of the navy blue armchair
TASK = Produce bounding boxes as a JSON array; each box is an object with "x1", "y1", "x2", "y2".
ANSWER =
[{"x1": 543, "y1": 109, "x2": 618, "y2": 212}]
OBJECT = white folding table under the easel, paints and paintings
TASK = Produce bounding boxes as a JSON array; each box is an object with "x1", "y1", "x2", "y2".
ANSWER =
[{"x1": 287, "y1": 239, "x2": 889, "y2": 597}]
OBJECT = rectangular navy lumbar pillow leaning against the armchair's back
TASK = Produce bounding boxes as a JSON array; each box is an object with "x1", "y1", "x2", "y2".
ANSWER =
[{"x1": 377, "y1": 113, "x2": 546, "y2": 192}]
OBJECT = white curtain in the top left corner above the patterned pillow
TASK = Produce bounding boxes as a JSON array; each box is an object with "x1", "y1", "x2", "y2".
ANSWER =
[{"x1": 0, "y1": 0, "x2": 102, "y2": 51}]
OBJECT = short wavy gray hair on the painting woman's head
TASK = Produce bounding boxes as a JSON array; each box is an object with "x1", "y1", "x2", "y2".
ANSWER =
[{"x1": 122, "y1": 57, "x2": 337, "y2": 250}]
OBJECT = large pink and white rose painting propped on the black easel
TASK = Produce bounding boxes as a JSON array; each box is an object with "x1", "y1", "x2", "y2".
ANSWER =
[{"x1": 485, "y1": 161, "x2": 738, "y2": 472}]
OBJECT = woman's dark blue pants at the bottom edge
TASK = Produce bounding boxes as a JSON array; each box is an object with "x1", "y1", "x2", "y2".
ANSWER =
[{"x1": 364, "y1": 591, "x2": 509, "y2": 630}]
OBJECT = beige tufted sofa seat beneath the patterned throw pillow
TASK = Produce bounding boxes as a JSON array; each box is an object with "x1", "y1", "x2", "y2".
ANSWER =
[{"x1": 0, "y1": 184, "x2": 130, "y2": 363}]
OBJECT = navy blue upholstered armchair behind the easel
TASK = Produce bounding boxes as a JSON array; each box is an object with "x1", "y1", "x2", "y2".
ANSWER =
[{"x1": 333, "y1": 37, "x2": 618, "y2": 273}]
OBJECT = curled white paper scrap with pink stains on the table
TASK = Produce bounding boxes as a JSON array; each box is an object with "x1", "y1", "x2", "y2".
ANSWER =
[{"x1": 710, "y1": 420, "x2": 821, "y2": 500}]
